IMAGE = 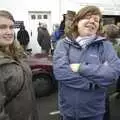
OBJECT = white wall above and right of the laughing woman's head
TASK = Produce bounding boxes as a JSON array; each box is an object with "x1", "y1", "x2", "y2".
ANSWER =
[{"x1": 64, "y1": 0, "x2": 120, "y2": 15}]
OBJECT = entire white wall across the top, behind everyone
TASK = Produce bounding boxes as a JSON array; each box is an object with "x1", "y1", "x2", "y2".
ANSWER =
[{"x1": 0, "y1": 0, "x2": 120, "y2": 30}]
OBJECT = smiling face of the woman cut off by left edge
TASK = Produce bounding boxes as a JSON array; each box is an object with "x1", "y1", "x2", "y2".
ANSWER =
[{"x1": 0, "y1": 16, "x2": 14, "y2": 46}]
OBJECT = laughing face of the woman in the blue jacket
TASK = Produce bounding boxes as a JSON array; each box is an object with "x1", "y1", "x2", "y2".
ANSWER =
[{"x1": 78, "y1": 15, "x2": 100, "y2": 37}]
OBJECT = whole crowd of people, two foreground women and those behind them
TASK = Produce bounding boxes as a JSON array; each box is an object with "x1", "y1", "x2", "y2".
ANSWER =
[{"x1": 0, "y1": 6, "x2": 120, "y2": 120}]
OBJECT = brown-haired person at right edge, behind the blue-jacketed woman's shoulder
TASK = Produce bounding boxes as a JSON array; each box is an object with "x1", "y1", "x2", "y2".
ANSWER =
[{"x1": 102, "y1": 24, "x2": 120, "y2": 120}]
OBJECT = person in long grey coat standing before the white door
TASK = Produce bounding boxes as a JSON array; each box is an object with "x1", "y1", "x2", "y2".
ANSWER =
[{"x1": 37, "y1": 23, "x2": 51, "y2": 54}]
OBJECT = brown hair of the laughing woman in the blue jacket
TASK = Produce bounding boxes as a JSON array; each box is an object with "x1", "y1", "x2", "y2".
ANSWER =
[{"x1": 67, "y1": 6, "x2": 102, "y2": 39}]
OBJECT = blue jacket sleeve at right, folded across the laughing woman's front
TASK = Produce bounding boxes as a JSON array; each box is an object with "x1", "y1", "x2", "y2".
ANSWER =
[{"x1": 79, "y1": 43, "x2": 120, "y2": 87}]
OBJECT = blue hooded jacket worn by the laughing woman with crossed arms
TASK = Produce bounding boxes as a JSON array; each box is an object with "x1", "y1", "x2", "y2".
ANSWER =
[{"x1": 53, "y1": 37, "x2": 120, "y2": 118}]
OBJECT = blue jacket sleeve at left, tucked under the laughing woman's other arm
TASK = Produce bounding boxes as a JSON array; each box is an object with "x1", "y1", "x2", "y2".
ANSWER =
[{"x1": 53, "y1": 40, "x2": 92, "y2": 90}]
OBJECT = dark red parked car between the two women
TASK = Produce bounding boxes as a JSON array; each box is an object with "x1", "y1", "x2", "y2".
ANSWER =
[{"x1": 27, "y1": 53, "x2": 57, "y2": 97}]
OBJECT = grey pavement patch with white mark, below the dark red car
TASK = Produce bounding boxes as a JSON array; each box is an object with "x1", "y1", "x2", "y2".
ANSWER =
[{"x1": 37, "y1": 92, "x2": 59, "y2": 120}]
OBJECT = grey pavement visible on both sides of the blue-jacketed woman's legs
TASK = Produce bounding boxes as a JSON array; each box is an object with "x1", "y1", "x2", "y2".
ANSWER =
[{"x1": 37, "y1": 92, "x2": 120, "y2": 120}]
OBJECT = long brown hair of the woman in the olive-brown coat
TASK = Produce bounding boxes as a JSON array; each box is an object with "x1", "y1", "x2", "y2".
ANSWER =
[{"x1": 0, "y1": 10, "x2": 24, "y2": 59}]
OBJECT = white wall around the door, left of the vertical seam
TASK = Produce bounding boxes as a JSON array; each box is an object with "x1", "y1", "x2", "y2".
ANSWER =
[{"x1": 0, "y1": 0, "x2": 60, "y2": 30}]
